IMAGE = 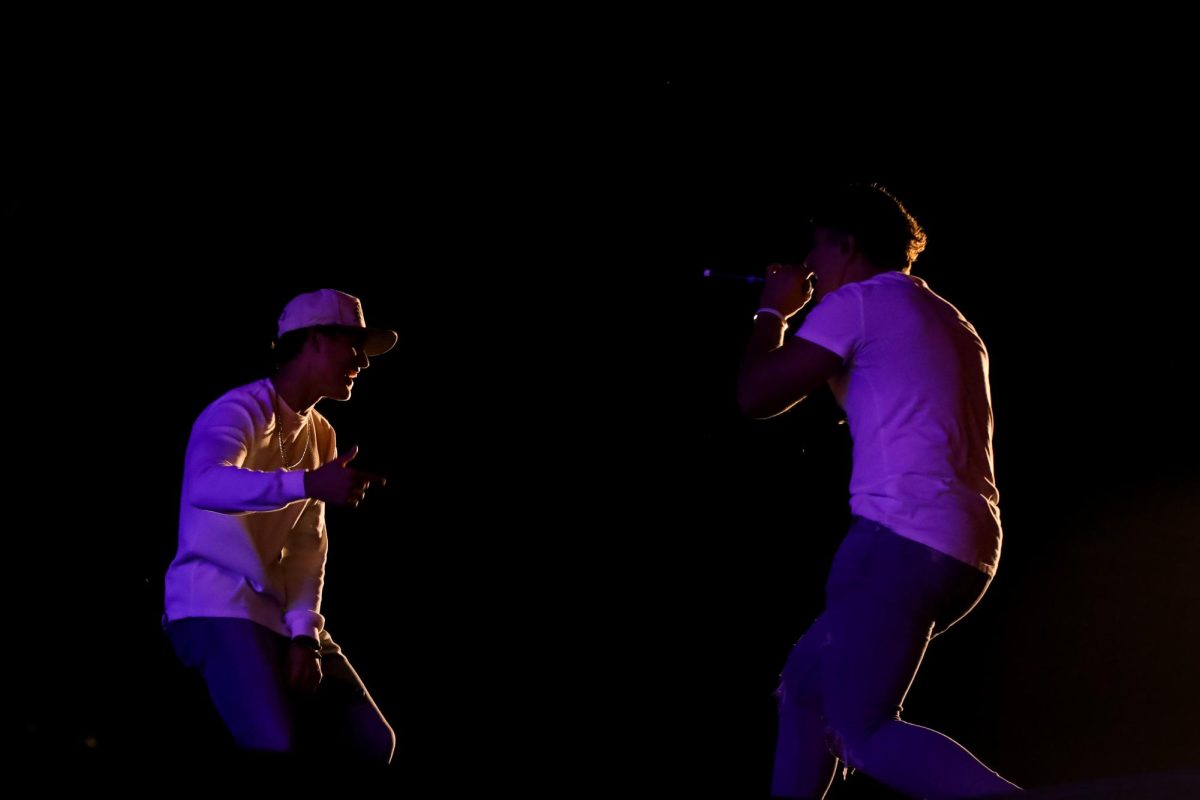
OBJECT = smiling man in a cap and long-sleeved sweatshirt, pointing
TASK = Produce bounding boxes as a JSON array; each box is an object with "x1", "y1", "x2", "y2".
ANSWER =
[{"x1": 163, "y1": 289, "x2": 397, "y2": 764}]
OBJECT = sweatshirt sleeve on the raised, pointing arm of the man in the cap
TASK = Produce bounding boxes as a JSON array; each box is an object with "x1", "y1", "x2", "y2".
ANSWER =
[{"x1": 184, "y1": 393, "x2": 305, "y2": 513}]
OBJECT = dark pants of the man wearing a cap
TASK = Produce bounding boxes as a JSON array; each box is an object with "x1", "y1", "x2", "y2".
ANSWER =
[{"x1": 166, "y1": 616, "x2": 396, "y2": 765}]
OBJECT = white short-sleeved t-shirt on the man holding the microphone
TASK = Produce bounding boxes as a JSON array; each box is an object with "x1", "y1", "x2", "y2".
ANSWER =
[{"x1": 796, "y1": 272, "x2": 1002, "y2": 575}]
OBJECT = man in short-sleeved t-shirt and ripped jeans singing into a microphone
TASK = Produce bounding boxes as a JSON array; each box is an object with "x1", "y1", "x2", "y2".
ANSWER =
[{"x1": 738, "y1": 186, "x2": 1020, "y2": 800}]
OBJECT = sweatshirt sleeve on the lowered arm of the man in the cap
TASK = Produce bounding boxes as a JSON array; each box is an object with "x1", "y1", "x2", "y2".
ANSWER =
[{"x1": 283, "y1": 429, "x2": 337, "y2": 639}]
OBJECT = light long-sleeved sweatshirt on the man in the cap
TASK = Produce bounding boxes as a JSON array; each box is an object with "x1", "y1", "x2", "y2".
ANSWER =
[{"x1": 164, "y1": 378, "x2": 337, "y2": 638}]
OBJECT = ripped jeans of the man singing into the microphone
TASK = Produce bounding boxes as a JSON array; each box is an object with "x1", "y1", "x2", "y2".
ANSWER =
[{"x1": 772, "y1": 517, "x2": 1018, "y2": 800}]
